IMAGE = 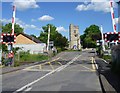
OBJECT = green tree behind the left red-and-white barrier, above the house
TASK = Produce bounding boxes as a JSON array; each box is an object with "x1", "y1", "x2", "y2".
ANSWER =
[{"x1": 2, "y1": 23, "x2": 24, "y2": 35}]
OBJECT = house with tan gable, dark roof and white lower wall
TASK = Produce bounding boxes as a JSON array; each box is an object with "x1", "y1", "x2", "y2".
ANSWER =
[{"x1": 13, "y1": 33, "x2": 46, "y2": 54}]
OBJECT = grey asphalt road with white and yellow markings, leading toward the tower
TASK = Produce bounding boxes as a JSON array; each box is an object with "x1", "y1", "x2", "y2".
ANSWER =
[{"x1": 2, "y1": 50, "x2": 102, "y2": 93}]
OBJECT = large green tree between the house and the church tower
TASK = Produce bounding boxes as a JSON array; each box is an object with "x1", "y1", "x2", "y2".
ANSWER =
[{"x1": 38, "y1": 24, "x2": 68, "y2": 48}]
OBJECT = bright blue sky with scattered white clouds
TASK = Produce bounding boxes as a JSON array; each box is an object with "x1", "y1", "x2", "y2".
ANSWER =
[{"x1": 0, "y1": 0, "x2": 120, "y2": 39}]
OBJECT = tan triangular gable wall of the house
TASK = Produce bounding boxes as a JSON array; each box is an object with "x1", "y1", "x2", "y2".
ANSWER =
[{"x1": 15, "y1": 34, "x2": 36, "y2": 44}]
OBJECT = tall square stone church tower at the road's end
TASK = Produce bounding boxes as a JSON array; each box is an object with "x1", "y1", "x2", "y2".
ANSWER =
[{"x1": 69, "y1": 24, "x2": 81, "y2": 50}]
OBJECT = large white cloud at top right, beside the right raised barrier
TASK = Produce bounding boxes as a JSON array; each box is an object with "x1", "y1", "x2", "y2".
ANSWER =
[{"x1": 76, "y1": 0, "x2": 116, "y2": 12}]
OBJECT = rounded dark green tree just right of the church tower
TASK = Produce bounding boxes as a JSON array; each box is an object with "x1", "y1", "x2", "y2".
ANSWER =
[{"x1": 80, "y1": 25, "x2": 101, "y2": 48}]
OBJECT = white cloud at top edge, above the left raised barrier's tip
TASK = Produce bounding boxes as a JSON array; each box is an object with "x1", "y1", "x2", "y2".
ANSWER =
[{"x1": 13, "y1": 0, "x2": 39, "y2": 10}]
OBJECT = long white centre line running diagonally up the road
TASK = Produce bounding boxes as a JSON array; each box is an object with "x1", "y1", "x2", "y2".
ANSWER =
[{"x1": 13, "y1": 55, "x2": 81, "y2": 93}]
